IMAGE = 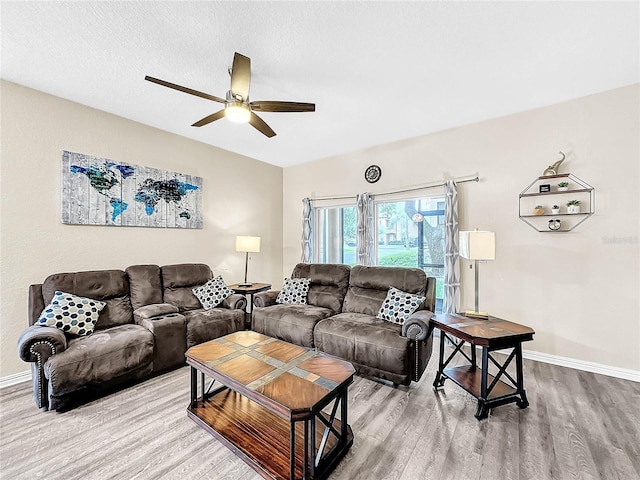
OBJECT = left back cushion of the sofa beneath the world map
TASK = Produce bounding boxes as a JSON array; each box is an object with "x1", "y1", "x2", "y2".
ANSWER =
[{"x1": 42, "y1": 270, "x2": 133, "y2": 330}]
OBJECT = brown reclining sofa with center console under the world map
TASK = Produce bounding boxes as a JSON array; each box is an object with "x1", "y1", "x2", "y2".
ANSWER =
[{"x1": 18, "y1": 264, "x2": 246, "y2": 410}]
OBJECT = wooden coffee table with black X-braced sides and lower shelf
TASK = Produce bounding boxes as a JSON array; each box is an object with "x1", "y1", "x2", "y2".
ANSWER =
[{"x1": 186, "y1": 331, "x2": 355, "y2": 480}]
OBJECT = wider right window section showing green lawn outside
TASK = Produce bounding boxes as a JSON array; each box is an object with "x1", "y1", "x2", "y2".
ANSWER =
[{"x1": 376, "y1": 196, "x2": 445, "y2": 312}]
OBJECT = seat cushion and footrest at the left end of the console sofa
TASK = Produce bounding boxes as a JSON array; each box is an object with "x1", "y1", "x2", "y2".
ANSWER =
[{"x1": 44, "y1": 324, "x2": 153, "y2": 395}]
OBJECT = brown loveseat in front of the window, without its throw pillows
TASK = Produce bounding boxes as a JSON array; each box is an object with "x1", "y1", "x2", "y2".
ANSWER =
[{"x1": 252, "y1": 263, "x2": 435, "y2": 385}]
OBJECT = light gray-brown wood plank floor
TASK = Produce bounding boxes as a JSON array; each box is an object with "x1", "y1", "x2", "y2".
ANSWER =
[{"x1": 0, "y1": 348, "x2": 640, "y2": 480}]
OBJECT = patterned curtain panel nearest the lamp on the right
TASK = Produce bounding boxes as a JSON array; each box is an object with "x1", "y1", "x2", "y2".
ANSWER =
[{"x1": 442, "y1": 180, "x2": 460, "y2": 313}]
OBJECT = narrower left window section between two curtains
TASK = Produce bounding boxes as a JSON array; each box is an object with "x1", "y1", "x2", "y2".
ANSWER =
[{"x1": 315, "y1": 207, "x2": 356, "y2": 266}]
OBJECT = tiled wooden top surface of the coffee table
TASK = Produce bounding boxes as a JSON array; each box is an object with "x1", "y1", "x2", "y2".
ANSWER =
[{"x1": 195, "y1": 330, "x2": 353, "y2": 410}]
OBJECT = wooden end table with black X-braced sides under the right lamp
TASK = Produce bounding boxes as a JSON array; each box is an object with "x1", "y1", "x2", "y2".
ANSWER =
[{"x1": 429, "y1": 314, "x2": 535, "y2": 420}]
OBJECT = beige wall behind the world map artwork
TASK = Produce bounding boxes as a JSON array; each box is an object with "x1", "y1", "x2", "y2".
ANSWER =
[{"x1": 0, "y1": 81, "x2": 283, "y2": 378}]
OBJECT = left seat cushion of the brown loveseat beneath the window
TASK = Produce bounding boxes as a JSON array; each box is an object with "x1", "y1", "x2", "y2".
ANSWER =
[{"x1": 251, "y1": 305, "x2": 333, "y2": 348}]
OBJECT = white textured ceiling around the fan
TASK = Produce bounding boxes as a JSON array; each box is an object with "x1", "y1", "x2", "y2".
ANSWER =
[{"x1": 0, "y1": 1, "x2": 640, "y2": 166}]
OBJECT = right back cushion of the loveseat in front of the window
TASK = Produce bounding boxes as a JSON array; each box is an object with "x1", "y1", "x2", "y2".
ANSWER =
[{"x1": 342, "y1": 265, "x2": 427, "y2": 316}]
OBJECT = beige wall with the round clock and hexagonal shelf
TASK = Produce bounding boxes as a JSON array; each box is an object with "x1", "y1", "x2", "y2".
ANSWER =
[{"x1": 283, "y1": 85, "x2": 640, "y2": 372}]
